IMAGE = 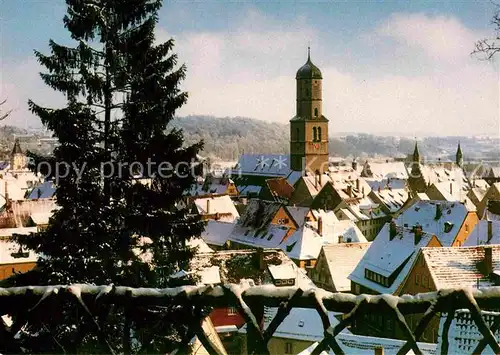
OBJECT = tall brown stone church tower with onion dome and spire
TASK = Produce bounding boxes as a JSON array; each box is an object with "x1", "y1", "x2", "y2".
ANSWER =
[{"x1": 290, "y1": 48, "x2": 328, "y2": 174}]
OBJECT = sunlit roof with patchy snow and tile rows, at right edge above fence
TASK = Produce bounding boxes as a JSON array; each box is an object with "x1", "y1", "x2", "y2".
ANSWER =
[{"x1": 422, "y1": 245, "x2": 500, "y2": 290}]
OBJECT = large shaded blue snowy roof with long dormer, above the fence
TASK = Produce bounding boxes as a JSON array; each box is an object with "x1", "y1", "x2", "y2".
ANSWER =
[{"x1": 349, "y1": 223, "x2": 433, "y2": 294}]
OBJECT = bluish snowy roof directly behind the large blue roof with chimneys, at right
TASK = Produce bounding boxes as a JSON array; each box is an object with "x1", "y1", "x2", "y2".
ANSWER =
[{"x1": 396, "y1": 200, "x2": 469, "y2": 246}]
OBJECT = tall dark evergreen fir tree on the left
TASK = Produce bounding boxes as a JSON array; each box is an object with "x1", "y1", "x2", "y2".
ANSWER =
[{"x1": 9, "y1": 0, "x2": 203, "y2": 353}]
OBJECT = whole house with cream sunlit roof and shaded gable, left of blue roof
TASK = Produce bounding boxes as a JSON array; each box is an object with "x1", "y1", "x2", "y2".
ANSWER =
[{"x1": 309, "y1": 243, "x2": 371, "y2": 292}]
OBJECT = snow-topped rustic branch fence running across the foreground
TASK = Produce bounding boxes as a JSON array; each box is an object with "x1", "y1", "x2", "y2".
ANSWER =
[{"x1": 0, "y1": 284, "x2": 500, "y2": 355}]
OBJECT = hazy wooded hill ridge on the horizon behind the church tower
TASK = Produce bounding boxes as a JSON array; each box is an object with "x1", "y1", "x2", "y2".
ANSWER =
[{"x1": 173, "y1": 116, "x2": 437, "y2": 160}]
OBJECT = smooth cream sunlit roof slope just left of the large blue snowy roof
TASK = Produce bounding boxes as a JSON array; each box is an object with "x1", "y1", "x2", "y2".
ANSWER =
[{"x1": 323, "y1": 243, "x2": 371, "y2": 292}]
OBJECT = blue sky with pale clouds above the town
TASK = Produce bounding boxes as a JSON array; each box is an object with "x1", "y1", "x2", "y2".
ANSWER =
[{"x1": 0, "y1": 0, "x2": 500, "y2": 137}]
